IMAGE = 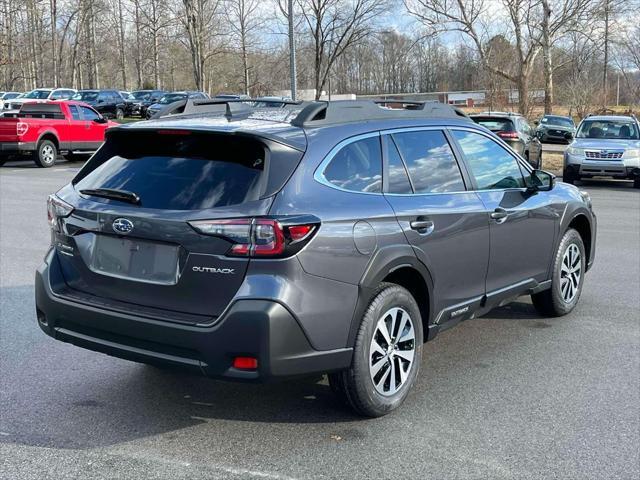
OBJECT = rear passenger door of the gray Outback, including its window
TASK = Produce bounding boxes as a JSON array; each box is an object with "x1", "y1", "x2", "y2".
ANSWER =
[{"x1": 382, "y1": 129, "x2": 489, "y2": 323}]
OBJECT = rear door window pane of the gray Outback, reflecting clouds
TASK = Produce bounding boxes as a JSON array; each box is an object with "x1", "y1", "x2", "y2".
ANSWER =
[{"x1": 393, "y1": 130, "x2": 465, "y2": 193}]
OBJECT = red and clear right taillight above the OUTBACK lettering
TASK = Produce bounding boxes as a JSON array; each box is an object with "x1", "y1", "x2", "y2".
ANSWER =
[{"x1": 189, "y1": 218, "x2": 320, "y2": 257}]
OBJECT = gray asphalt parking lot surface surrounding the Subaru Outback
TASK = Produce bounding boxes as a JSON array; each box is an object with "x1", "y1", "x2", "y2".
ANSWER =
[{"x1": 0, "y1": 163, "x2": 640, "y2": 480}]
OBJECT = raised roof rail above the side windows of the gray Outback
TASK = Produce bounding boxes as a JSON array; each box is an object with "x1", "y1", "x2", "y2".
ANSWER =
[{"x1": 291, "y1": 100, "x2": 469, "y2": 127}]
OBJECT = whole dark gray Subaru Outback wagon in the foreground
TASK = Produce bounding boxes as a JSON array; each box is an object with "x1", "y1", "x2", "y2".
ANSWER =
[{"x1": 35, "y1": 100, "x2": 596, "y2": 416}]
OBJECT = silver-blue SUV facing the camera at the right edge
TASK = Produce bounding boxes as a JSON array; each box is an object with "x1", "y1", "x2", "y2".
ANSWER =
[{"x1": 562, "y1": 115, "x2": 640, "y2": 188}]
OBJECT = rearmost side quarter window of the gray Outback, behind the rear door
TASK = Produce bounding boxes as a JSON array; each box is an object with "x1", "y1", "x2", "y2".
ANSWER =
[{"x1": 324, "y1": 136, "x2": 382, "y2": 193}]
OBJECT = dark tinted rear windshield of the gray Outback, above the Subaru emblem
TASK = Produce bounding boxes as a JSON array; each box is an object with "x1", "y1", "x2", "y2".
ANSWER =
[{"x1": 74, "y1": 131, "x2": 266, "y2": 210}]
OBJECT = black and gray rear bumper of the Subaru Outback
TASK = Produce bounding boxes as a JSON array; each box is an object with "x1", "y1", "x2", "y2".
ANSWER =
[{"x1": 35, "y1": 252, "x2": 352, "y2": 382}]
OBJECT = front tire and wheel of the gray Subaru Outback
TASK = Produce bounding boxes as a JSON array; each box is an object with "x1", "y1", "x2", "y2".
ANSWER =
[{"x1": 531, "y1": 228, "x2": 587, "y2": 317}]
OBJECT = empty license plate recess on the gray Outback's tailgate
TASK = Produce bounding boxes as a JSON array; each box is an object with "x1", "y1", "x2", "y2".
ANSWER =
[{"x1": 87, "y1": 235, "x2": 180, "y2": 285}]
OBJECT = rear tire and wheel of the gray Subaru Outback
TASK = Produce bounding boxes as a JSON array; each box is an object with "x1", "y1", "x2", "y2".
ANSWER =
[{"x1": 329, "y1": 283, "x2": 423, "y2": 417}]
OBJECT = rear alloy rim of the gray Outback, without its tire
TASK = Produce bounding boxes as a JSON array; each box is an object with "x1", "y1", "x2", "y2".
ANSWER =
[{"x1": 369, "y1": 307, "x2": 416, "y2": 396}]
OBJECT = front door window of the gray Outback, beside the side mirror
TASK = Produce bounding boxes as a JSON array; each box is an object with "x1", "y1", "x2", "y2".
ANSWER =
[{"x1": 453, "y1": 130, "x2": 525, "y2": 190}]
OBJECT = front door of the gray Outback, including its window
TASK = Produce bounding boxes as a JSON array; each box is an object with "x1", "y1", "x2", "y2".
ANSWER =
[{"x1": 451, "y1": 129, "x2": 559, "y2": 306}]
